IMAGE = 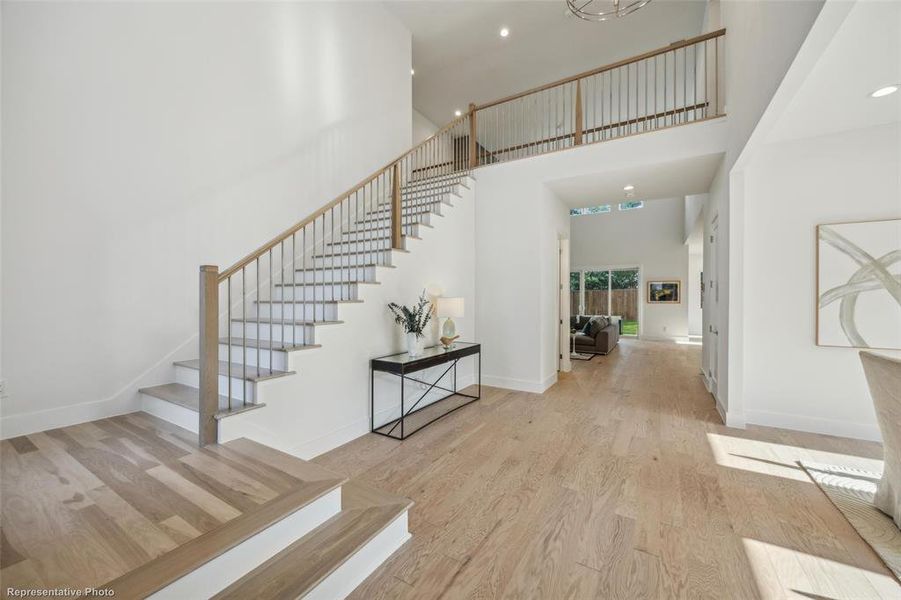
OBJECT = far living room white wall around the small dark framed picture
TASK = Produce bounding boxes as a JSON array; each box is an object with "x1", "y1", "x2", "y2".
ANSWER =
[{"x1": 570, "y1": 197, "x2": 688, "y2": 339}]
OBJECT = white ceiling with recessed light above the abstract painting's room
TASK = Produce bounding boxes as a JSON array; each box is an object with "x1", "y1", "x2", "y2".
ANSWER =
[{"x1": 767, "y1": 1, "x2": 901, "y2": 142}]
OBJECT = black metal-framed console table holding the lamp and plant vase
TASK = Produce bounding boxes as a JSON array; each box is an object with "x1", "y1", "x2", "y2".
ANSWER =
[{"x1": 369, "y1": 342, "x2": 482, "y2": 440}]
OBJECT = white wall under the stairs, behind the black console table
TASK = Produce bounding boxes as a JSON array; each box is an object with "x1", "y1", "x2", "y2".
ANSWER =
[{"x1": 220, "y1": 185, "x2": 478, "y2": 458}]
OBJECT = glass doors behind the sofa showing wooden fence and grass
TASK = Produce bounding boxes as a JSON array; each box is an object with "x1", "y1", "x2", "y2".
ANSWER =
[{"x1": 570, "y1": 267, "x2": 641, "y2": 336}]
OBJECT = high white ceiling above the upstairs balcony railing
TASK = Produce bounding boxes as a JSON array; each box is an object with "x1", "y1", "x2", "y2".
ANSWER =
[{"x1": 385, "y1": 0, "x2": 706, "y2": 126}]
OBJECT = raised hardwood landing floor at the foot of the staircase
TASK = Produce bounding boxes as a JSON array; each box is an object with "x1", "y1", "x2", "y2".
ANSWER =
[{"x1": 0, "y1": 413, "x2": 344, "y2": 599}]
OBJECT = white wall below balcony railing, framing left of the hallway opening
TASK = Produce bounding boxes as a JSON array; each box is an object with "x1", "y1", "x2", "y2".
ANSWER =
[{"x1": 475, "y1": 120, "x2": 726, "y2": 392}]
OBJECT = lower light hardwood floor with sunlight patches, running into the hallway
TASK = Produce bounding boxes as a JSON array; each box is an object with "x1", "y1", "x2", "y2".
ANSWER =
[{"x1": 316, "y1": 340, "x2": 901, "y2": 600}]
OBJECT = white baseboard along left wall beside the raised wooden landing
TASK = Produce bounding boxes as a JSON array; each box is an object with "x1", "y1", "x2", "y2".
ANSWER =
[{"x1": 0, "y1": 393, "x2": 141, "y2": 440}]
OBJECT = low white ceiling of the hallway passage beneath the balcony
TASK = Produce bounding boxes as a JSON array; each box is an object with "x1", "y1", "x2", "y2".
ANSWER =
[{"x1": 548, "y1": 153, "x2": 723, "y2": 208}]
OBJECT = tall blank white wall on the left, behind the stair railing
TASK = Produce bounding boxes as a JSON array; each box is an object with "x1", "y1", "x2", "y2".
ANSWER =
[{"x1": 2, "y1": 2, "x2": 412, "y2": 436}]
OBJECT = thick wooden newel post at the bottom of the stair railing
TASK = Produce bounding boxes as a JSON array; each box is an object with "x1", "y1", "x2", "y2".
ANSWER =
[{"x1": 197, "y1": 265, "x2": 219, "y2": 446}]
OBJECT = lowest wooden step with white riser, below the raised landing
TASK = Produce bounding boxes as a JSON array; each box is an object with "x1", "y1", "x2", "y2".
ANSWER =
[{"x1": 214, "y1": 481, "x2": 413, "y2": 600}]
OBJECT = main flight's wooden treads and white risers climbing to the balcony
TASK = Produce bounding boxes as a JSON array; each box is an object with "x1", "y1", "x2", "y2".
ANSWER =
[{"x1": 140, "y1": 173, "x2": 471, "y2": 433}]
